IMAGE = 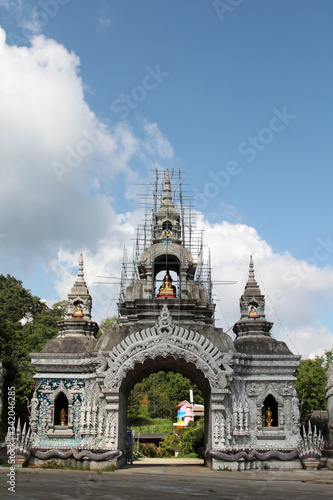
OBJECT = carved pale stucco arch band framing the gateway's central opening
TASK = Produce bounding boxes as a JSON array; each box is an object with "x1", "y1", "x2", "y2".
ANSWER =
[{"x1": 100, "y1": 305, "x2": 233, "y2": 466}]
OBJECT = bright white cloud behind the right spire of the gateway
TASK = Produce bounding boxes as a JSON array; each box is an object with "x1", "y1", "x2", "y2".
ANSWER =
[{"x1": 197, "y1": 214, "x2": 333, "y2": 358}]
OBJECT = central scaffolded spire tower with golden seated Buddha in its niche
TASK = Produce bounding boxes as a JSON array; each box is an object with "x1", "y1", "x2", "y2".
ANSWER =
[{"x1": 118, "y1": 169, "x2": 215, "y2": 324}]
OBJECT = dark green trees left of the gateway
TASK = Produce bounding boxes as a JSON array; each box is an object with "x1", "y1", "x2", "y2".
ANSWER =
[{"x1": 0, "y1": 275, "x2": 63, "y2": 432}]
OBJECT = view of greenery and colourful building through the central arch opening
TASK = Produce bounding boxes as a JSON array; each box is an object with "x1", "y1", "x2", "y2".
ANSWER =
[{"x1": 127, "y1": 370, "x2": 204, "y2": 458}]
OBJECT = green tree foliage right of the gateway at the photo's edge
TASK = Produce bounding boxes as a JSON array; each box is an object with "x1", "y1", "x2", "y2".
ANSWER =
[{"x1": 295, "y1": 349, "x2": 333, "y2": 421}]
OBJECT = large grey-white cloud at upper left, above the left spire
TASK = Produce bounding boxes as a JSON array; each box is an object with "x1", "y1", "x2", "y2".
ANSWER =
[{"x1": 0, "y1": 29, "x2": 175, "y2": 267}]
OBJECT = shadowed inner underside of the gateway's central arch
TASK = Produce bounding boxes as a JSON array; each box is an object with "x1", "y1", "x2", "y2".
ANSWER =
[{"x1": 119, "y1": 356, "x2": 211, "y2": 464}]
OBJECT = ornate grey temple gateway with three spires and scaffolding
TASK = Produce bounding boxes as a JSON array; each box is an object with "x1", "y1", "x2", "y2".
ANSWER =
[{"x1": 30, "y1": 171, "x2": 302, "y2": 469}]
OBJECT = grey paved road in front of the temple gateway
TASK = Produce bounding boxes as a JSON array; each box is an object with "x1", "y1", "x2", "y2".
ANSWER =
[{"x1": 0, "y1": 462, "x2": 333, "y2": 500}]
